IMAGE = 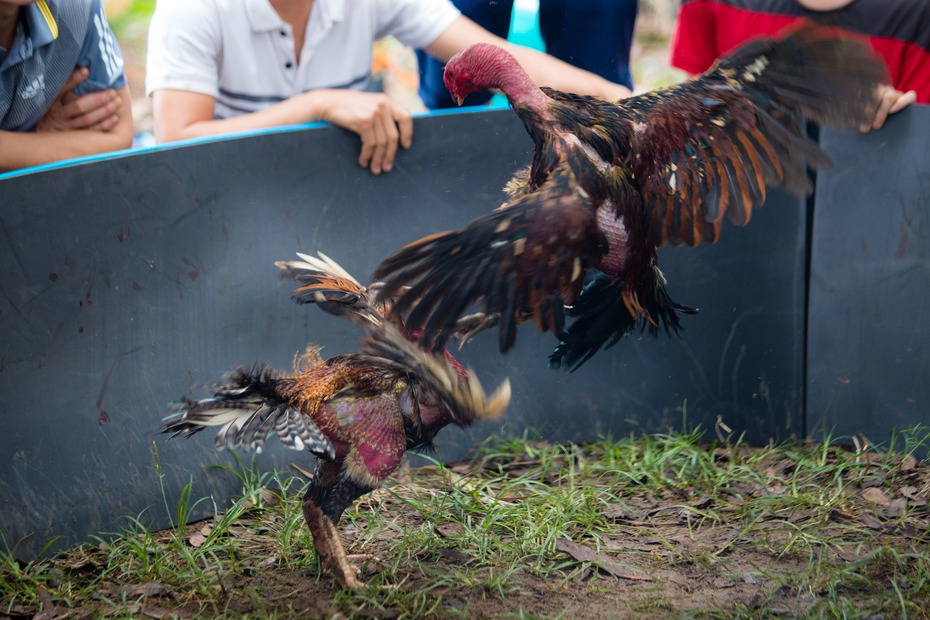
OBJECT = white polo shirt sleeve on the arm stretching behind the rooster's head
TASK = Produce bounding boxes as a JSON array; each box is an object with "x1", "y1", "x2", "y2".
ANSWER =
[{"x1": 375, "y1": 0, "x2": 460, "y2": 49}]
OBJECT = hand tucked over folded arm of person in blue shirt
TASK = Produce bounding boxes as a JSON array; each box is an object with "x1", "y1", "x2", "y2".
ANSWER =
[{"x1": 36, "y1": 67, "x2": 123, "y2": 132}]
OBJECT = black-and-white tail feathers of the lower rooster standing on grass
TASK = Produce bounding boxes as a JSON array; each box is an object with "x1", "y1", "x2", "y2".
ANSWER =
[{"x1": 163, "y1": 365, "x2": 335, "y2": 458}]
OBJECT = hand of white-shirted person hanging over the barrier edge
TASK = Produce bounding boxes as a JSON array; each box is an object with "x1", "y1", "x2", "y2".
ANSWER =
[{"x1": 323, "y1": 90, "x2": 413, "y2": 174}]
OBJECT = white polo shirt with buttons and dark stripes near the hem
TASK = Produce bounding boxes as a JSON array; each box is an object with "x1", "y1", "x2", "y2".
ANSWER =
[{"x1": 145, "y1": 0, "x2": 459, "y2": 118}]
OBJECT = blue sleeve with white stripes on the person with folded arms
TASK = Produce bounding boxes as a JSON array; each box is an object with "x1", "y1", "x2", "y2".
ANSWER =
[{"x1": 73, "y1": 0, "x2": 126, "y2": 95}]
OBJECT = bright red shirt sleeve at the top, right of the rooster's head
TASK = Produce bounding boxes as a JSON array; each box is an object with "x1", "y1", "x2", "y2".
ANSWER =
[{"x1": 670, "y1": 0, "x2": 721, "y2": 74}]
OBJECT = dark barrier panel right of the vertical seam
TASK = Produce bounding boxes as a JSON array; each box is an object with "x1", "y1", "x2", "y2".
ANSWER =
[{"x1": 807, "y1": 106, "x2": 930, "y2": 446}]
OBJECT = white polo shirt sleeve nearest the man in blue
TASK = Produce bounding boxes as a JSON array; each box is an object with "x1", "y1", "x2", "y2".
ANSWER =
[{"x1": 145, "y1": 0, "x2": 223, "y2": 97}]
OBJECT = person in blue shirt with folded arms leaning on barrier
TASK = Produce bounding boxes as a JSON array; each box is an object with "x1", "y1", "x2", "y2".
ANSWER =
[{"x1": 0, "y1": 0, "x2": 133, "y2": 172}]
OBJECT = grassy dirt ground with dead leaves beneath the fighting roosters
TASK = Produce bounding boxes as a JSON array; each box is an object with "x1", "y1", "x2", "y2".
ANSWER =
[{"x1": 9, "y1": 438, "x2": 930, "y2": 620}]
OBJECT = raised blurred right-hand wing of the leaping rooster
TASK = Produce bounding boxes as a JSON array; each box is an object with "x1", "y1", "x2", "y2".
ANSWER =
[{"x1": 621, "y1": 25, "x2": 885, "y2": 245}]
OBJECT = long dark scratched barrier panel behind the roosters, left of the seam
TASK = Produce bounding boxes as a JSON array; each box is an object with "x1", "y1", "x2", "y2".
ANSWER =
[{"x1": 0, "y1": 110, "x2": 806, "y2": 558}]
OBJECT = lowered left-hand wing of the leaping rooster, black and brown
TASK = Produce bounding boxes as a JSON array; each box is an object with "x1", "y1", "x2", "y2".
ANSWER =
[{"x1": 374, "y1": 163, "x2": 604, "y2": 351}]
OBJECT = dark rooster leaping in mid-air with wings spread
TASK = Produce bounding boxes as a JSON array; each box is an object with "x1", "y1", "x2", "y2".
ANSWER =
[{"x1": 374, "y1": 24, "x2": 886, "y2": 370}]
